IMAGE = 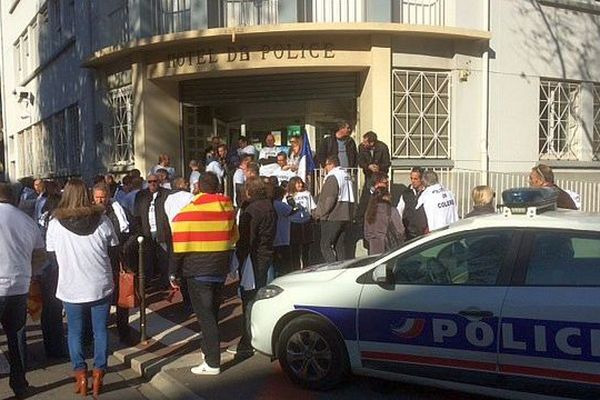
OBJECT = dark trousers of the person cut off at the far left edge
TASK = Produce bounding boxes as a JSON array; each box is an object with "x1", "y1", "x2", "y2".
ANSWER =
[{"x1": 0, "y1": 294, "x2": 28, "y2": 393}]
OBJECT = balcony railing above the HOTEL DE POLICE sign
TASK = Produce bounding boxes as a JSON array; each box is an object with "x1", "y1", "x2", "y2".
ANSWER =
[{"x1": 149, "y1": 0, "x2": 448, "y2": 34}]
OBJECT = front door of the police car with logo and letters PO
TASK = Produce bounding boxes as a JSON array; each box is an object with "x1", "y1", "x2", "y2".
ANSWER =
[{"x1": 358, "y1": 229, "x2": 519, "y2": 384}]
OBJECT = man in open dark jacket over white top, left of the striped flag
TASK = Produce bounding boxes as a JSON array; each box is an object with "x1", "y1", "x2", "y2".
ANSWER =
[{"x1": 134, "y1": 174, "x2": 171, "y2": 287}]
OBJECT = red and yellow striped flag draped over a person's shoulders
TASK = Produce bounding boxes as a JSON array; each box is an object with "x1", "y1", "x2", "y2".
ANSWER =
[{"x1": 173, "y1": 193, "x2": 238, "y2": 253}]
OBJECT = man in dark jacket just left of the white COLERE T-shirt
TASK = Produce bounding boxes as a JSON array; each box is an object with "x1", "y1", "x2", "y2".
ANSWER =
[{"x1": 397, "y1": 167, "x2": 427, "y2": 240}]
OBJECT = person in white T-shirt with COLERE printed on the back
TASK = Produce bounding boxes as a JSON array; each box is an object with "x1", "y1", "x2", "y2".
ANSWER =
[{"x1": 415, "y1": 171, "x2": 458, "y2": 232}]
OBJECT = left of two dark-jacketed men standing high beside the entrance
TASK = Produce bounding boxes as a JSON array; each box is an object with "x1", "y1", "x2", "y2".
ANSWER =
[{"x1": 317, "y1": 121, "x2": 358, "y2": 168}]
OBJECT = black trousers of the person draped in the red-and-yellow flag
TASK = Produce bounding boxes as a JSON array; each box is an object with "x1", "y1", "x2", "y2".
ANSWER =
[{"x1": 187, "y1": 278, "x2": 224, "y2": 368}]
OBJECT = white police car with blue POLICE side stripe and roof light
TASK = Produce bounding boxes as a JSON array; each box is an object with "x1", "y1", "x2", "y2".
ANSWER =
[{"x1": 251, "y1": 188, "x2": 600, "y2": 399}]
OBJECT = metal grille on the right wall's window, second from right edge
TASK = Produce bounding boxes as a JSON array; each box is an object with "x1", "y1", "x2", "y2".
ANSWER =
[{"x1": 539, "y1": 81, "x2": 581, "y2": 160}]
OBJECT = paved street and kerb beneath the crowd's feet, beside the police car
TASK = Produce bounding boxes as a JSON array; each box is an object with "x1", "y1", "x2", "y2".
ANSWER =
[{"x1": 0, "y1": 282, "x2": 492, "y2": 400}]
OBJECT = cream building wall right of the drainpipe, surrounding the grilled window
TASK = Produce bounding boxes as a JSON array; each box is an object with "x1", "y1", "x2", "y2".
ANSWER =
[{"x1": 490, "y1": 0, "x2": 600, "y2": 172}]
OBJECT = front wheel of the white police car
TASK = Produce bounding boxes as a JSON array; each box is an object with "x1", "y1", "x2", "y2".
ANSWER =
[{"x1": 277, "y1": 315, "x2": 349, "y2": 390}]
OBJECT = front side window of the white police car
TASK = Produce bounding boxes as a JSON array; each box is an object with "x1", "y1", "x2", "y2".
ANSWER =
[{"x1": 388, "y1": 231, "x2": 512, "y2": 285}]
